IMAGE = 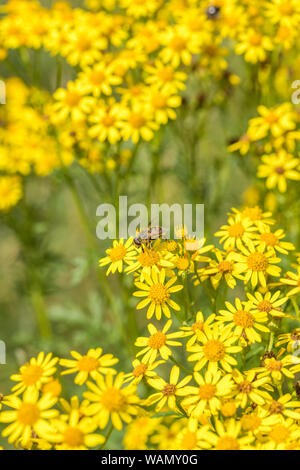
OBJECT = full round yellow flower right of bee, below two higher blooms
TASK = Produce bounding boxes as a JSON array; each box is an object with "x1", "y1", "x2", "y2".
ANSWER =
[{"x1": 233, "y1": 244, "x2": 281, "y2": 287}]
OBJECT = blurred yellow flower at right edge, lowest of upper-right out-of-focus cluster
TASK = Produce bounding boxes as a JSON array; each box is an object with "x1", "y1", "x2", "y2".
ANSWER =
[{"x1": 257, "y1": 149, "x2": 300, "y2": 193}]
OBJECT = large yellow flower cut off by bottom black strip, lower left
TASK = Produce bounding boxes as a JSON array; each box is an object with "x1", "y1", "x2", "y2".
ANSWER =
[{"x1": 51, "y1": 410, "x2": 105, "y2": 450}]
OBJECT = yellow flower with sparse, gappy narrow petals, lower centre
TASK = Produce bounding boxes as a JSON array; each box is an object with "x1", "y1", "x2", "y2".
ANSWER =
[{"x1": 145, "y1": 366, "x2": 192, "y2": 412}]
